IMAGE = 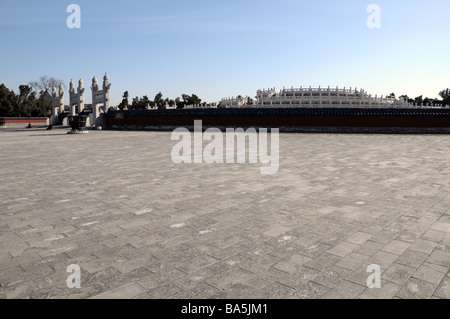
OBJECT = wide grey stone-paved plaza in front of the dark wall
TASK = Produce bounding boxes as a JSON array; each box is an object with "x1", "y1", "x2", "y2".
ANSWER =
[{"x1": 0, "y1": 126, "x2": 450, "y2": 299}]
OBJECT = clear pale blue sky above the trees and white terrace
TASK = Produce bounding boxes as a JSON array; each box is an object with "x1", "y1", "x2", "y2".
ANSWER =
[{"x1": 0, "y1": 0, "x2": 450, "y2": 105}]
